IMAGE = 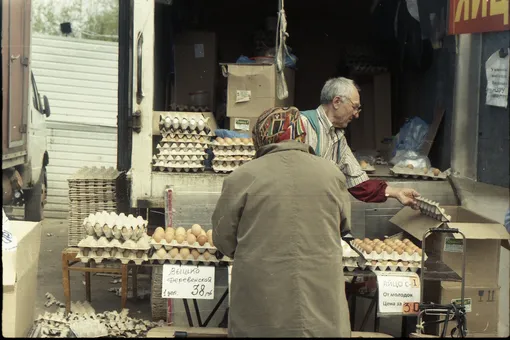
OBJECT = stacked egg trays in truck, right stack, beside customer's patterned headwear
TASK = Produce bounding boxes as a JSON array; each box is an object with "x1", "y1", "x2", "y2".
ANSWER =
[{"x1": 212, "y1": 137, "x2": 255, "y2": 173}]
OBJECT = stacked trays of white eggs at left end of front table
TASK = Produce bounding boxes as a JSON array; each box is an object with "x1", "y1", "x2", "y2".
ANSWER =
[{"x1": 77, "y1": 211, "x2": 151, "y2": 265}]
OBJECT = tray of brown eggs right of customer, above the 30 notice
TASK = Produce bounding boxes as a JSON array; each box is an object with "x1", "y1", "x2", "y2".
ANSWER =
[{"x1": 351, "y1": 242, "x2": 427, "y2": 273}]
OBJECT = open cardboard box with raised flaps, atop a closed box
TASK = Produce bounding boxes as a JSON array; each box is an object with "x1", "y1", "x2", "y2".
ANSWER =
[{"x1": 390, "y1": 206, "x2": 510, "y2": 287}]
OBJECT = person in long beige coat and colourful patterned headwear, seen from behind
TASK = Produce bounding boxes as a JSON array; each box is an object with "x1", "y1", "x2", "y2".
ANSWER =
[{"x1": 212, "y1": 108, "x2": 351, "y2": 337}]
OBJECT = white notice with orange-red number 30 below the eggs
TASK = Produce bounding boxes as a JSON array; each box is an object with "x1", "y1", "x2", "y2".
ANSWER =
[{"x1": 377, "y1": 272, "x2": 420, "y2": 315}]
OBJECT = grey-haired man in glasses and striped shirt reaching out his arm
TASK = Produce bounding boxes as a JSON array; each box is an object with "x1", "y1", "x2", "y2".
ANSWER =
[{"x1": 301, "y1": 77, "x2": 419, "y2": 209}]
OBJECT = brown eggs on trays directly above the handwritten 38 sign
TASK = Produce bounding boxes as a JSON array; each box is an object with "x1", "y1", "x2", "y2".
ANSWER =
[{"x1": 150, "y1": 224, "x2": 232, "y2": 264}]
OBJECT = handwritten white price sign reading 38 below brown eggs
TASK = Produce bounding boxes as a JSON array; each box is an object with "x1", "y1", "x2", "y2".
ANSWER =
[{"x1": 161, "y1": 264, "x2": 216, "y2": 300}]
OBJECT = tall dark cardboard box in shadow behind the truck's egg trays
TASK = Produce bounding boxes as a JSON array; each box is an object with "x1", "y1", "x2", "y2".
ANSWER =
[{"x1": 173, "y1": 32, "x2": 218, "y2": 109}]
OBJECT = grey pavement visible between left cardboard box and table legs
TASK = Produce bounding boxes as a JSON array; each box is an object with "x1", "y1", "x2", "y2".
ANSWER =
[{"x1": 35, "y1": 219, "x2": 151, "y2": 320}]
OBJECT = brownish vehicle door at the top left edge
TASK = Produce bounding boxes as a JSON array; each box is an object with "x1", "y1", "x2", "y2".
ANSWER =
[{"x1": 2, "y1": 0, "x2": 31, "y2": 152}]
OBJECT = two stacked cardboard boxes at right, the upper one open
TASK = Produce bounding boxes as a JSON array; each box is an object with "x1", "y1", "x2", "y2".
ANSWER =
[{"x1": 390, "y1": 206, "x2": 510, "y2": 336}]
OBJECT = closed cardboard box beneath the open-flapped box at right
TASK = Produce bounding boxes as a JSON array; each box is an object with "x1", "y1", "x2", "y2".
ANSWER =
[{"x1": 426, "y1": 282, "x2": 500, "y2": 337}]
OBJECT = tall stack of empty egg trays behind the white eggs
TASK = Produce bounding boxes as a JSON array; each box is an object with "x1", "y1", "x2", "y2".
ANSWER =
[{"x1": 67, "y1": 167, "x2": 129, "y2": 247}]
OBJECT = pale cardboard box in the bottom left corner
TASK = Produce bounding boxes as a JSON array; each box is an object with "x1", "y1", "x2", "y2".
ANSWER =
[{"x1": 2, "y1": 221, "x2": 41, "y2": 338}]
